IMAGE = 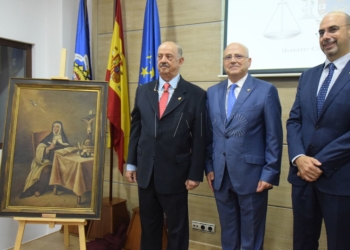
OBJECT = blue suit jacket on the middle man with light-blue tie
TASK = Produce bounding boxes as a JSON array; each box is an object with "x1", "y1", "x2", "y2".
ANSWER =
[{"x1": 206, "y1": 75, "x2": 282, "y2": 195}]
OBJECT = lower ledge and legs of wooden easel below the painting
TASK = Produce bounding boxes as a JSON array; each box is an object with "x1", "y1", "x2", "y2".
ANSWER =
[{"x1": 13, "y1": 217, "x2": 86, "y2": 250}]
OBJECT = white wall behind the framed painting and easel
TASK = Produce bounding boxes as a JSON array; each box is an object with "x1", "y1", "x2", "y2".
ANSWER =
[{"x1": 0, "y1": 0, "x2": 85, "y2": 250}]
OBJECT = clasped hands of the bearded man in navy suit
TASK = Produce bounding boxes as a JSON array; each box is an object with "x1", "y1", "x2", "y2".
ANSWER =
[{"x1": 295, "y1": 155, "x2": 322, "y2": 182}]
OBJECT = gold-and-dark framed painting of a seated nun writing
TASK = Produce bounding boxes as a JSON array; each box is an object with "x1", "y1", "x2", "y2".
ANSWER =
[{"x1": 0, "y1": 78, "x2": 108, "y2": 219}]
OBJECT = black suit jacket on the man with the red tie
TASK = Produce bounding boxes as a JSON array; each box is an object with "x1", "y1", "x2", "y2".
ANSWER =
[{"x1": 127, "y1": 77, "x2": 206, "y2": 194}]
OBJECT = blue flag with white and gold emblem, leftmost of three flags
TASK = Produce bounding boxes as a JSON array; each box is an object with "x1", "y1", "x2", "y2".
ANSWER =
[{"x1": 73, "y1": 0, "x2": 92, "y2": 80}]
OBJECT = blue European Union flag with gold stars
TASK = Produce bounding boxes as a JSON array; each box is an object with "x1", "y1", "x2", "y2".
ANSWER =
[{"x1": 139, "y1": 0, "x2": 160, "y2": 85}]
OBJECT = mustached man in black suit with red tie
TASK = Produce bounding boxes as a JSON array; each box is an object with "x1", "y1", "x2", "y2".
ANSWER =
[{"x1": 126, "y1": 42, "x2": 206, "y2": 250}]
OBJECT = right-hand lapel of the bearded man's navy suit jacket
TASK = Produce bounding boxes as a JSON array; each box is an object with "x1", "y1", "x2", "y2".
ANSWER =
[{"x1": 320, "y1": 62, "x2": 350, "y2": 117}]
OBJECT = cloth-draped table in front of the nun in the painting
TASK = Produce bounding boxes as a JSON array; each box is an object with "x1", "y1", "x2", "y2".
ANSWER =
[{"x1": 49, "y1": 153, "x2": 94, "y2": 204}]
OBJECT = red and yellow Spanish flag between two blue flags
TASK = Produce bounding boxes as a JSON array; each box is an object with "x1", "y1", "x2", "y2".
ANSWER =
[{"x1": 106, "y1": 0, "x2": 130, "y2": 174}]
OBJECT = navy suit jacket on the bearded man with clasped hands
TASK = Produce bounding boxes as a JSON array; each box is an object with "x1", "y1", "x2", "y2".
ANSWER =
[{"x1": 287, "y1": 62, "x2": 350, "y2": 196}]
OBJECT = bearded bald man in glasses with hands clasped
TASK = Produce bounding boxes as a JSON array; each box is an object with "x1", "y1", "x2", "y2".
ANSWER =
[{"x1": 287, "y1": 12, "x2": 350, "y2": 250}]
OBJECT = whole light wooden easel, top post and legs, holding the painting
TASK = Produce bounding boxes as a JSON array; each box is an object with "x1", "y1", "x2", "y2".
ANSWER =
[{"x1": 13, "y1": 48, "x2": 87, "y2": 250}]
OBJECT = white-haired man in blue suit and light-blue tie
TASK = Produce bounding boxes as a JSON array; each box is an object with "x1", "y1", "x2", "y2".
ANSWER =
[{"x1": 205, "y1": 43, "x2": 282, "y2": 250}]
